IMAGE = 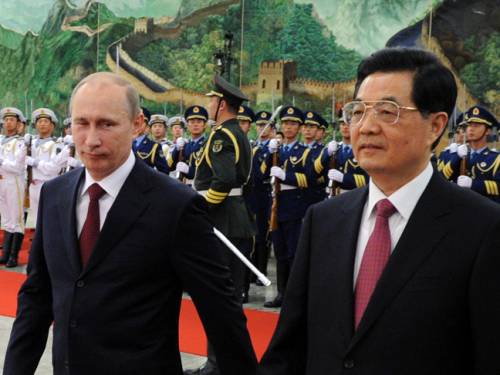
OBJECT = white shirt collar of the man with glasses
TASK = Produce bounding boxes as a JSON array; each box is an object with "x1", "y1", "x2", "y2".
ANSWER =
[{"x1": 367, "y1": 163, "x2": 433, "y2": 220}]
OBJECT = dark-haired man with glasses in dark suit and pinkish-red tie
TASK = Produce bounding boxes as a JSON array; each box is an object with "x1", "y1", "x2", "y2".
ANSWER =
[{"x1": 258, "y1": 49, "x2": 500, "y2": 375}]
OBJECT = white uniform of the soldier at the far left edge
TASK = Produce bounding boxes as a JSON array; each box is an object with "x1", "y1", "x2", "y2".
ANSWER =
[{"x1": 0, "y1": 135, "x2": 26, "y2": 234}]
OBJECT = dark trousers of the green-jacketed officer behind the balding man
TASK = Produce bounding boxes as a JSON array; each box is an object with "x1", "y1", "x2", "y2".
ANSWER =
[{"x1": 206, "y1": 238, "x2": 253, "y2": 369}]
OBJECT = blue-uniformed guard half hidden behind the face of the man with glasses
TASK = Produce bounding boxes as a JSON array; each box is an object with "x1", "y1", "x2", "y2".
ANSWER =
[{"x1": 314, "y1": 113, "x2": 368, "y2": 195}]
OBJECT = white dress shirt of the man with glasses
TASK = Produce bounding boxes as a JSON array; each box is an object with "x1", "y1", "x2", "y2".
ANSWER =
[{"x1": 353, "y1": 163, "x2": 433, "y2": 288}]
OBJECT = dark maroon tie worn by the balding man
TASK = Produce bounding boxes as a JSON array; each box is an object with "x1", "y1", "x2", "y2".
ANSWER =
[{"x1": 80, "y1": 183, "x2": 106, "y2": 267}]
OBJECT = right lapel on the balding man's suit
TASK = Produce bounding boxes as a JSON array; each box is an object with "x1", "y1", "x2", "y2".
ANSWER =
[{"x1": 81, "y1": 159, "x2": 152, "y2": 276}]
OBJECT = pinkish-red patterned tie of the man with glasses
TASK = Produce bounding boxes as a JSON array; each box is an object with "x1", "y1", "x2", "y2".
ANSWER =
[{"x1": 354, "y1": 199, "x2": 396, "y2": 328}]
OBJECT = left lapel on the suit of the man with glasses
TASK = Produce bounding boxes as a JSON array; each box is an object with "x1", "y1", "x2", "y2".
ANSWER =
[{"x1": 325, "y1": 187, "x2": 368, "y2": 347}]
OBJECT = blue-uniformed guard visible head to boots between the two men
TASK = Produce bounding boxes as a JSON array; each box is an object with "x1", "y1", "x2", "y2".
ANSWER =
[{"x1": 262, "y1": 106, "x2": 314, "y2": 307}]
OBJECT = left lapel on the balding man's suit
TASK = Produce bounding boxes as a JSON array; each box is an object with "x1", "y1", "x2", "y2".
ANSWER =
[{"x1": 59, "y1": 168, "x2": 85, "y2": 274}]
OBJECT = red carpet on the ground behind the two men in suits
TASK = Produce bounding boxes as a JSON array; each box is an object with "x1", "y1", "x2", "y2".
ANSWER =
[{"x1": 0, "y1": 270, "x2": 278, "y2": 359}]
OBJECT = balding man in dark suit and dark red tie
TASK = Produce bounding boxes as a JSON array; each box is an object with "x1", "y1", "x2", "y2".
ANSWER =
[{"x1": 4, "y1": 73, "x2": 256, "y2": 375}]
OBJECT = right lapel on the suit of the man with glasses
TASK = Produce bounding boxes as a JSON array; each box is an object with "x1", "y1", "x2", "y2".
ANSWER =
[{"x1": 349, "y1": 172, "x2": 451, "y2": 350}]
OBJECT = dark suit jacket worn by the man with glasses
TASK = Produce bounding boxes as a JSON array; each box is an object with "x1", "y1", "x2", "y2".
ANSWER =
[{"x1": 258, "y1": 173, "x2": 500, "y2": 375}]
